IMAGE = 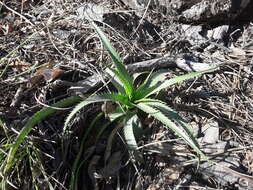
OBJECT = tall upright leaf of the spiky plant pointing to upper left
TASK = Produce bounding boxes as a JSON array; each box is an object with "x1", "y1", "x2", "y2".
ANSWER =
[{"x1": 92, "y1": 22, "x2": 134, "y2": 97}]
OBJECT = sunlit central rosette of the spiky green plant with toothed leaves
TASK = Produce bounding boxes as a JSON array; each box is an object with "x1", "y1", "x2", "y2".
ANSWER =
[{"x1": 64, "y1": 23, "x2": 215, "y2": 159}]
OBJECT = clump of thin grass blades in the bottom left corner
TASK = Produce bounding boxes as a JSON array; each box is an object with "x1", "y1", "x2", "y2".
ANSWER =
[{"x1": 0, "y1": 120, "x2": 53, "y2": 190}]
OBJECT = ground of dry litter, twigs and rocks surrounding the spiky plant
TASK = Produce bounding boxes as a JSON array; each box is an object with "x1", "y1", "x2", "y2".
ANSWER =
[{"x1": 0, "y1": 0, "x2": 253, "y2": 190}]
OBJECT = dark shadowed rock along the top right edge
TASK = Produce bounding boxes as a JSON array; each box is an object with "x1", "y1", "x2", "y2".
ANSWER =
[{"x1": 144, "y1": 0, "x2": 253, "y2": 24}]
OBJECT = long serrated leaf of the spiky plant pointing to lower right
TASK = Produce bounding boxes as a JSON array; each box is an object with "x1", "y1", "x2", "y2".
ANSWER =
[{"x1": 136, "y1": 103, "x2": 203, "y2": 155}]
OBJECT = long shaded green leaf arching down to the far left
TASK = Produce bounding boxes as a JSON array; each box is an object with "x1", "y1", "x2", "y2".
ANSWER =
[{"x1": 4, "y1": 97, "x2": 81, "y2": 173}]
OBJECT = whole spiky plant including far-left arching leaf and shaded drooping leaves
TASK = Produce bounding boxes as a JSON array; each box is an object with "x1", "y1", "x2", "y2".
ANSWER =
[{"x1": 1, "y1": 23, "x2": 213, "y2": 189}]
